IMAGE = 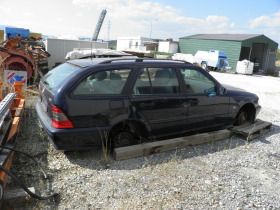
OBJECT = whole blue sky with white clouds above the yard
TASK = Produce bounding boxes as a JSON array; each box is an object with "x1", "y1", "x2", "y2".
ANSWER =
[{"x1": 0, "y1": 0, "x2": 280, "y2": 43}]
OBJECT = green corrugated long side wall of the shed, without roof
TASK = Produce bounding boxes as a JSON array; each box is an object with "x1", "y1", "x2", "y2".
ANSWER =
[{"x1": 179, "y1": 38, "x2": 241, "y2": 72}]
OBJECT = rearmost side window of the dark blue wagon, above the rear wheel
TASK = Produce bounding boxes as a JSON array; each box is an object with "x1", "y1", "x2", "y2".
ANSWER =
[{"x1": 73, "y1": 69, "x2": 131, "y2": 96}]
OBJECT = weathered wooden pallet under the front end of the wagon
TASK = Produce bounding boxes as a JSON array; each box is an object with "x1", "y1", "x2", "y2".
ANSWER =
[{"x1": 231, "y1": 119, "x2": 272, "y2": 140}]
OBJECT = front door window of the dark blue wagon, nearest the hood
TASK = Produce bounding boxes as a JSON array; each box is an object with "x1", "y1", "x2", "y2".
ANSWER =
[{"x1": 181, "y1": 69, "x2": 215, "y2": 93}]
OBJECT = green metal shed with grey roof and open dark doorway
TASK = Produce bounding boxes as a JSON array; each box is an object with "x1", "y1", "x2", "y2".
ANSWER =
[{"x1": 179, "y1": 34, "x2": 278, "y2": 73}]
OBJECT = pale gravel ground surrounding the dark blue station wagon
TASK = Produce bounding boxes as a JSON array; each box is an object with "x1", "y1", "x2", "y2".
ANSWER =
[{"x1": 4, "y1": 72, "x2": 280, "y2": 209}]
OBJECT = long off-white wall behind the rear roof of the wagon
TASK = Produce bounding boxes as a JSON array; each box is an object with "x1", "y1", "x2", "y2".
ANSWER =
[{"x1": 46, "y1": 38, "x2": 108, "y2": 68}]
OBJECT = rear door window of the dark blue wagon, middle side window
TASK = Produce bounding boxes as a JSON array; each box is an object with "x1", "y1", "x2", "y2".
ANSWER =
[{"x1": 133, "y1": 68, "x2": 180, "y2": 95}]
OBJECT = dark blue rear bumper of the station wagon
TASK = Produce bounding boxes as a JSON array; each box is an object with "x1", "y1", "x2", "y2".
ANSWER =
[{"x1": 36, "y1": 102, "x2": 110, "y2": 151}]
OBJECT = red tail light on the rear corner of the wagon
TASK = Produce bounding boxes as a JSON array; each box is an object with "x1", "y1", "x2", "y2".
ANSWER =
[{"x1": 52, "y1": 106, "x2": 74, "y2": 128}]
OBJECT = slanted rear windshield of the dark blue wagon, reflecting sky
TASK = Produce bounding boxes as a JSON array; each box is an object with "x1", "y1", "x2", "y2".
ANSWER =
[{"x1": 42, "y1": 63, "x2": 82, "y2": 92}]
